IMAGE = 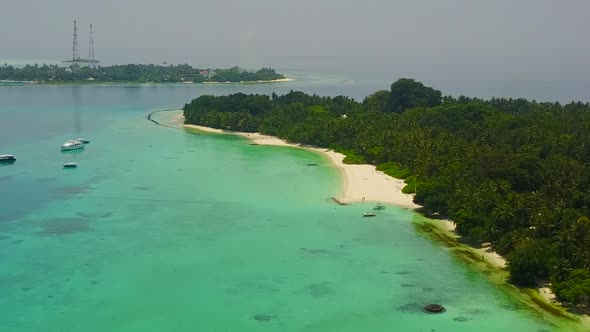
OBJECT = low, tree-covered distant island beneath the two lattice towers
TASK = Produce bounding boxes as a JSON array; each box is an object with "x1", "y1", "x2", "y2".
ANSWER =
[{"x1": 0, "y1": 64, "x2": 285, "y2": 83}]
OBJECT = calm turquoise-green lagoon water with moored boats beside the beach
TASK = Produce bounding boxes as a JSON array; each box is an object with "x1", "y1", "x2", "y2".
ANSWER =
[{"x1": 0, "y1": 75, "x2": 580, "y2": 332}]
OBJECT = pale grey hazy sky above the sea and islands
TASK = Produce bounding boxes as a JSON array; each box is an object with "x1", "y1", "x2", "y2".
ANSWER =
[{"x1": 0, "y1": 0, "x2": 590, "y2": 99}]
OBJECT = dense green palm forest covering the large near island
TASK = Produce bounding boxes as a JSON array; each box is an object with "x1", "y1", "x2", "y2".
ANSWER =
[{"x1": 184, "y1": 79, "x2": 590, "y2": 309}]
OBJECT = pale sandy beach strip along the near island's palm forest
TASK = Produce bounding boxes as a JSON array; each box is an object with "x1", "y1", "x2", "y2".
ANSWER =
[{"x1": 174, "y1": 113, "x2": 590, "y2": 327}]
